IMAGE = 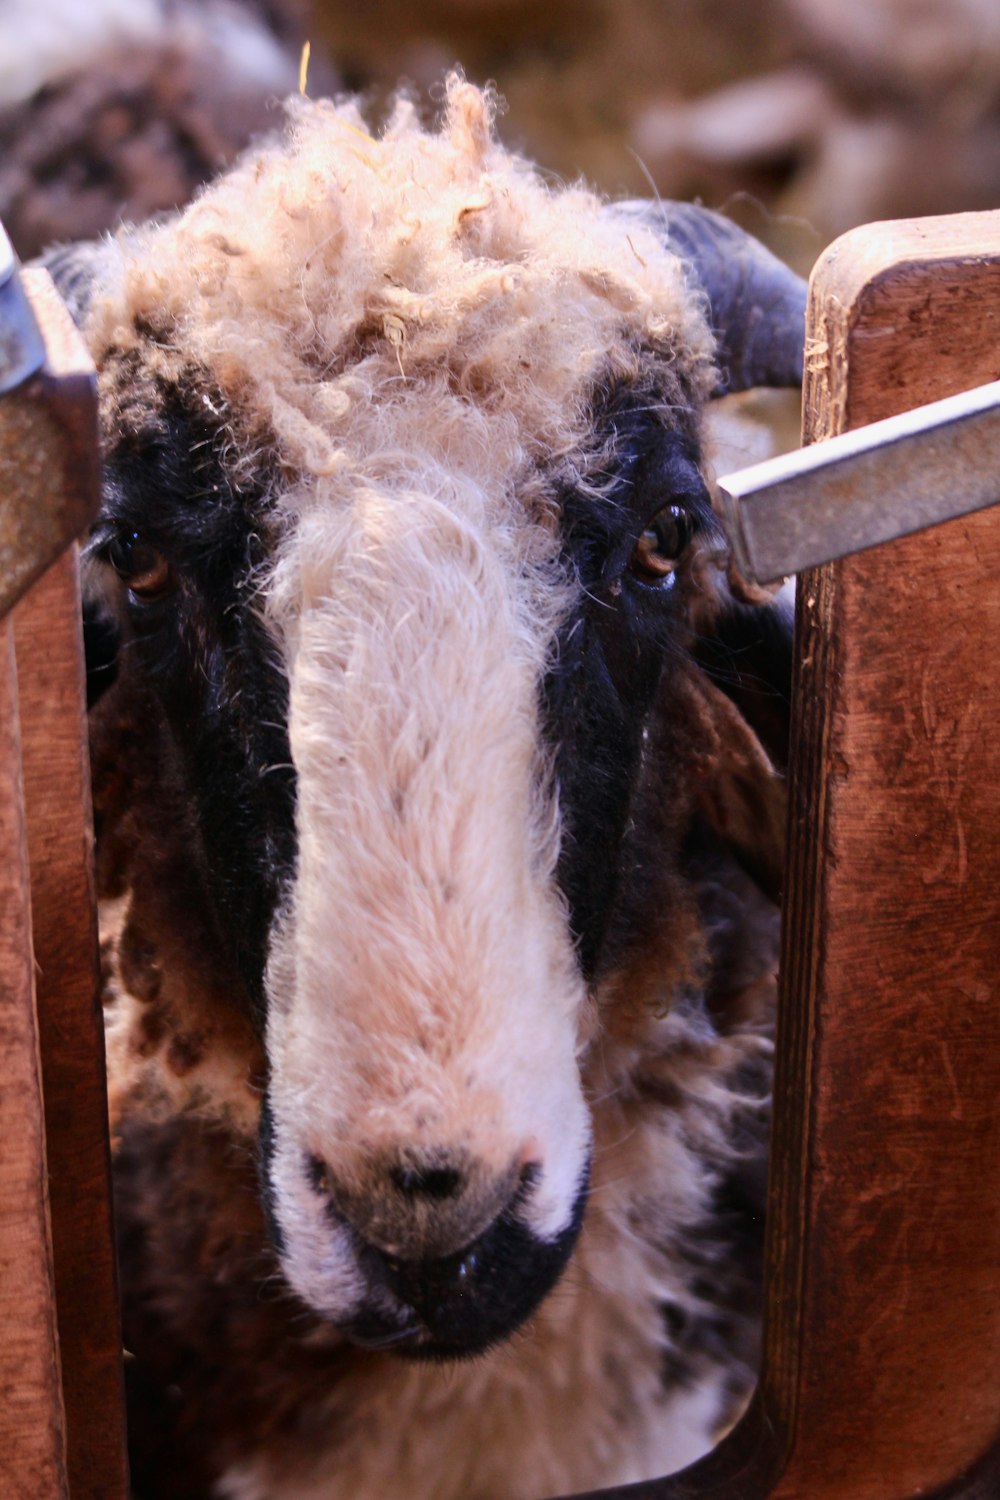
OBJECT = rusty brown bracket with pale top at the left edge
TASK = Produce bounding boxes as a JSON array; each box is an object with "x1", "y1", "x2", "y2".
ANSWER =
[{"x1": 0, "y1": 243, "x2": 99, "y2": 617}]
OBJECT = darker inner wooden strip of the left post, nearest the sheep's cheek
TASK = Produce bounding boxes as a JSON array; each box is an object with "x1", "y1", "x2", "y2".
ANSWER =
[{"x1": 13, "y1": 548, "x2": 127, "y2": 1500}]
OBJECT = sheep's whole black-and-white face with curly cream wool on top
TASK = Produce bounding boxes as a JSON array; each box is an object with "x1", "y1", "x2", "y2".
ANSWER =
[{"x1": 70, "y1": 84, "x2": 803, "y2": 1358}]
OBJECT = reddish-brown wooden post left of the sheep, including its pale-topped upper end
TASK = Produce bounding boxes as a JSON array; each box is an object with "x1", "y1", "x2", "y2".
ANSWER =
[{"x1": 0, "y1": 272, "x2": 127, "y2": 1500}]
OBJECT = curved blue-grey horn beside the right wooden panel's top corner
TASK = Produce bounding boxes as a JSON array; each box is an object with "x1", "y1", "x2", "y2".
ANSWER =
[{"x1": 618, "y1": 201, "x2": 805, "y2": 396}]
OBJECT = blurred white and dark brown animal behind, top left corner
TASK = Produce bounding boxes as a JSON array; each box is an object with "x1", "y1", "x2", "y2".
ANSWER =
[{"x1": 0, "y1": 0, "x2": 333, "y2": 260}]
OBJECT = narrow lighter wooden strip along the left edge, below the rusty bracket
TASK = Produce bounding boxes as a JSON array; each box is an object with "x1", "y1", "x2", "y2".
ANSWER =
[{"x1": 0, "y1": 621, "x2": 67, "y2": 1500}]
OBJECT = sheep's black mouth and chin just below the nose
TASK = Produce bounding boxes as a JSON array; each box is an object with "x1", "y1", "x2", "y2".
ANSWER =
[{"x1": 342, "y1": 1163, "x2": 589, "y2": 1362}]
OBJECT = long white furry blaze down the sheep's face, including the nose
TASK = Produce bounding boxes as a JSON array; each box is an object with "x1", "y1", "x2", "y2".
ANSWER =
[{"x1": 267, "y1": 471, "x2": 589, "y2": 1352}]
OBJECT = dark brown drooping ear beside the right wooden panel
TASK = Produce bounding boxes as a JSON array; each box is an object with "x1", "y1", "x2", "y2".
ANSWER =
[{"x1": 696, "y1": 600, "x2": 792, "y2": 902}]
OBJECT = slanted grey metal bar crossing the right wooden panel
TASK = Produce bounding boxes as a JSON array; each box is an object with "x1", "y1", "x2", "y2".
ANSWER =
[{"x1": 718, "y1": 381, "x2": 1000, "y2": 582}]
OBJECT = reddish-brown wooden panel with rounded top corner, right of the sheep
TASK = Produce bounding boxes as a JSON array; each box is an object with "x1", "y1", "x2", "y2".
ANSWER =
[{"x1": 563, "y1": 213, "x2": 1000, "y2": 1500}]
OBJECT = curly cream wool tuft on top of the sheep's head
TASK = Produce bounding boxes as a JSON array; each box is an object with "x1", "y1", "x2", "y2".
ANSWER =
[{"x1": 88, "y1": 75, "x2": 714, "y2": 479}]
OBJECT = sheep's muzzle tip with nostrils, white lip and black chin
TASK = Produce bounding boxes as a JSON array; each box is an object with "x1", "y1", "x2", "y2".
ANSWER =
[{"x1": 261, "y1": 1104, "x2": 589, "y2": 1361}]
